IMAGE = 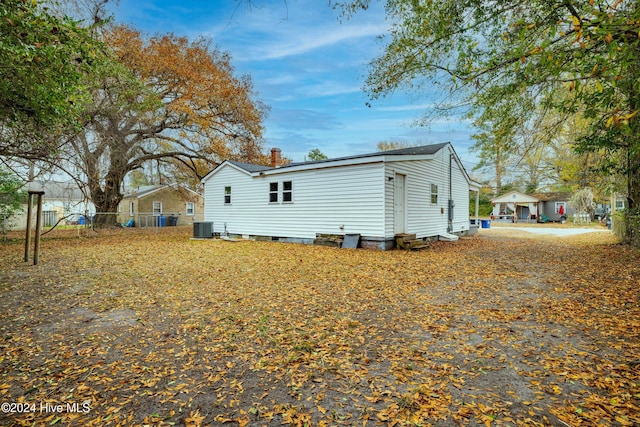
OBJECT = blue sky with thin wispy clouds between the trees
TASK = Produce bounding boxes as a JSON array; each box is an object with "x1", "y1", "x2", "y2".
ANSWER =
[{"x1": 113, "y1": 0, "x2": 477, "y2": 168}]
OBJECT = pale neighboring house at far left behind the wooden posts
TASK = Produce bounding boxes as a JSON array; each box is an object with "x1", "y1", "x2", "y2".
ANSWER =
[{"x1": 8, "y1": 181, "x2": 96, "y2": 230}]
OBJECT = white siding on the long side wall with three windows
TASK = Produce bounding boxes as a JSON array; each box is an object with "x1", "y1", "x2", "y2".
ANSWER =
[{"x1": 204, "y1": 163, "x2": 385, "y2": 238}]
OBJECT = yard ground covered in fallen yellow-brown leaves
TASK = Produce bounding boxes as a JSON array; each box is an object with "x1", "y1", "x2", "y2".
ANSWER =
[{"x1": 0, "y1": 228, "x2": 640, "y2": 427}]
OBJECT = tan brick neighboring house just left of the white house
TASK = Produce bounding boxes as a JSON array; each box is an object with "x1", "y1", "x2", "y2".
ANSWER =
[{"x1": 118, "y1": 184, "x2": 204, "y2": 227}]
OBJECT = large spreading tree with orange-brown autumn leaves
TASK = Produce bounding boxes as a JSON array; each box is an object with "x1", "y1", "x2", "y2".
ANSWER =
[{"x1": 61, "y1": 26, "x2": 266, "y2": 224}]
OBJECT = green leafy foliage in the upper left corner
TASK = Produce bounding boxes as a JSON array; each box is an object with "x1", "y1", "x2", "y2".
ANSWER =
[{"x1": 0, "y1": 0, "x2": 101, "y2": 158}]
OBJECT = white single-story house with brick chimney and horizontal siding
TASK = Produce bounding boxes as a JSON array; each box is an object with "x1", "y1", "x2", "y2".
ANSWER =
[{"x1": 202, "y1": 143, "x2": 480, "y2": 249}]
